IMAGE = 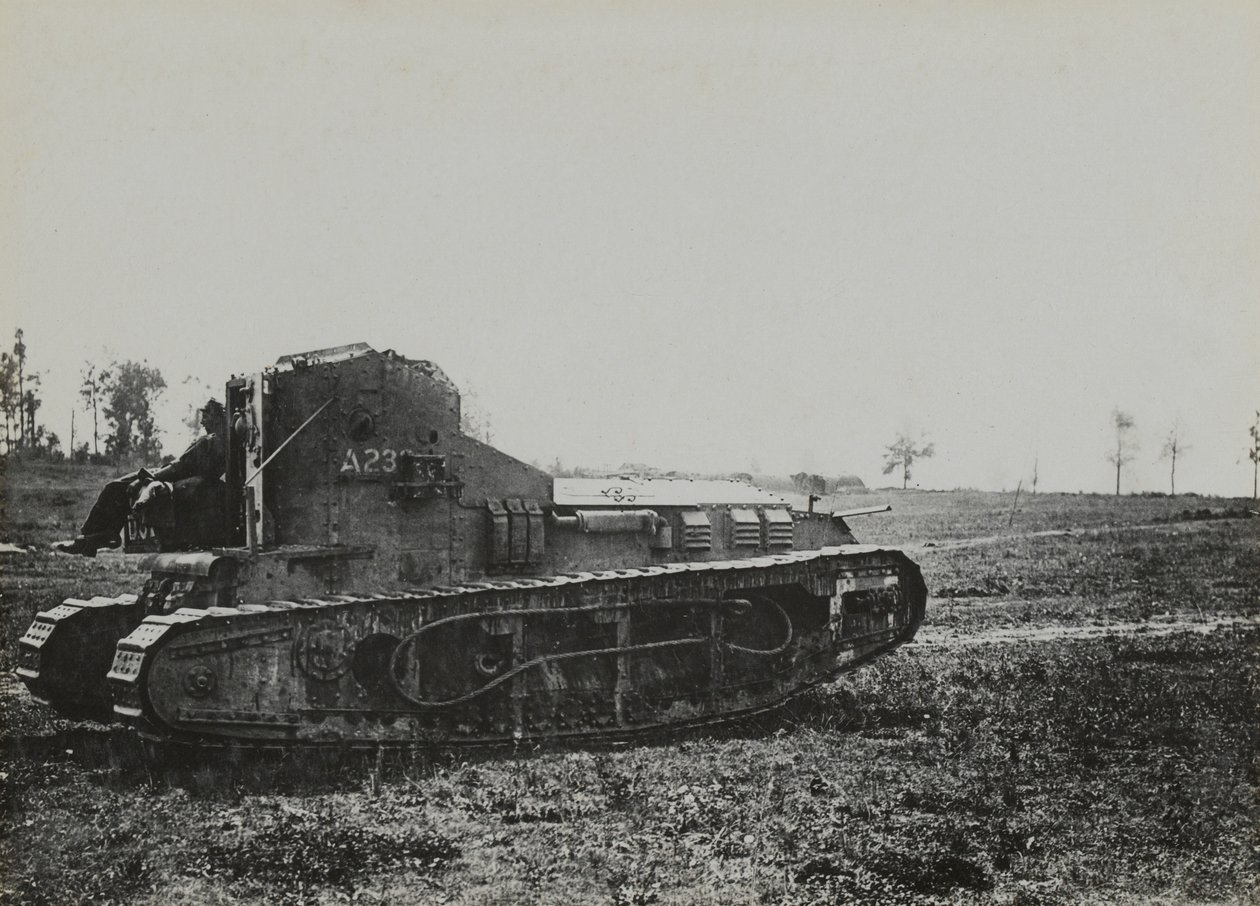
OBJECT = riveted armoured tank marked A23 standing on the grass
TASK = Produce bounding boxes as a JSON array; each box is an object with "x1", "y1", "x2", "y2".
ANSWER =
[{"x1": 18, "y1": 344, "x2": 927, "y2": 746}]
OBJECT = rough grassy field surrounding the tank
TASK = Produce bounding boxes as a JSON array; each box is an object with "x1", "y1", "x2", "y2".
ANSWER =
[{"x1": 0, "y1": 467, "x2": 1260, "y2": 906}]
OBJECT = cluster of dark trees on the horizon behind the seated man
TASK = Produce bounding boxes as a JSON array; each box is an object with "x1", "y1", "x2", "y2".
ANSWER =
[{"x1": 0, "y1": 328, "x2": 166, "y2": 462}]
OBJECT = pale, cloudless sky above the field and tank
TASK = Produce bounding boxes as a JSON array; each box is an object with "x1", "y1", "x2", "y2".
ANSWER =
[{"x1": 0, "y1": 0, "x2": 1260, "y2": 495}]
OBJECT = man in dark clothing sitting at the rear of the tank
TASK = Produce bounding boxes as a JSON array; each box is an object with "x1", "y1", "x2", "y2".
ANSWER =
[{"x1": 53, "y1": 399, "x2": 227, "y2": 557}]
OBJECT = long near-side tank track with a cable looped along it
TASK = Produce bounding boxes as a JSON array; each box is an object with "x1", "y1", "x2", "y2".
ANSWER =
[{"x1": 108, "y1": 546, "x2": 926, "y2": 746}]
